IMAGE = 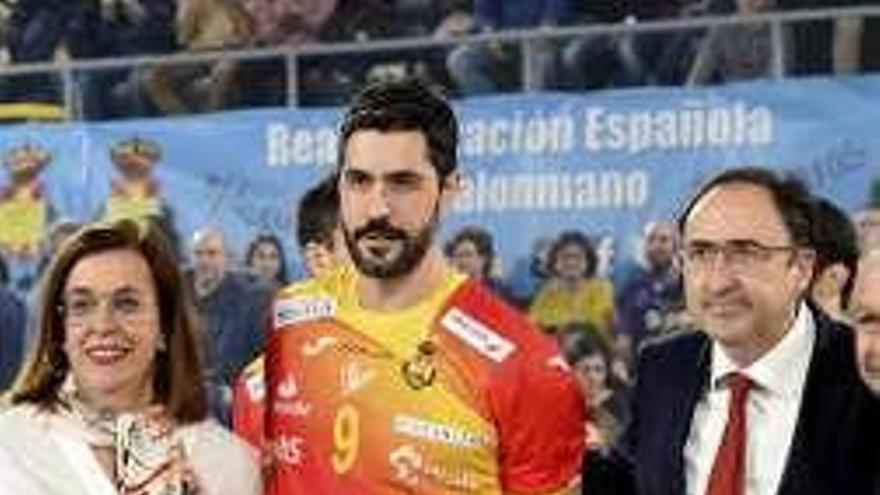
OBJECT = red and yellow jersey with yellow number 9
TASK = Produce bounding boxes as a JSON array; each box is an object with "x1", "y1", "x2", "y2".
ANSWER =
[{"x1": 266, "y1": 267, "x2": 585, "y2": 495}]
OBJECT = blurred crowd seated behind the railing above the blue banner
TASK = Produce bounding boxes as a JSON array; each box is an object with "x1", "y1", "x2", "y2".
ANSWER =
[{"x1": 0, "y1": 0, "x2": 877, "y2": 119}]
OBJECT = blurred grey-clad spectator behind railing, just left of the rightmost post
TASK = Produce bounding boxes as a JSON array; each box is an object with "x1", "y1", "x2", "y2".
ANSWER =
[{"x1": 688, "y1": 0, "x2": 776, "y2": 84}]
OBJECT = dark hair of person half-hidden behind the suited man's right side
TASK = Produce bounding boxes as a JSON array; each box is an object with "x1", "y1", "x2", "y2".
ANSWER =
[{"x1": 813, "y1": 197, "x2": 859, "y2": 307}]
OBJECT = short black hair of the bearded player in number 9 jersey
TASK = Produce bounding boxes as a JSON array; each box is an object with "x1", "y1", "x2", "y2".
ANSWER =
[{"x1": 337, "y1": 78, "x2": 458, "y2": 182}]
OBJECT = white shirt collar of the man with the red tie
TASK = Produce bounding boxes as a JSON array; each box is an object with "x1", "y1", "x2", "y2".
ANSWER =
[{"x1": 710, "y1": 303, "x2": 816, "y2": 396}]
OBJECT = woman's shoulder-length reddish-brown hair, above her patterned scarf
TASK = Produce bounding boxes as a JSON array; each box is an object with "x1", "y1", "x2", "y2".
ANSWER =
[{"x1": 12, "y1": 218, "x2": 208, "y2": 423}]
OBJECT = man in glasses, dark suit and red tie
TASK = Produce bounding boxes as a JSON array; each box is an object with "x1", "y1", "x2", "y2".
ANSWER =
[{"x1": 592, "y1": 168, "x2": 880, "y2": 495}]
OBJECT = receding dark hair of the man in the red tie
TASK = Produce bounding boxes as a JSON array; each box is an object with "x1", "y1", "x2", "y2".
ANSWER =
[{"x1": 677, "y1": 167, "x2": 815, "y2": 252}]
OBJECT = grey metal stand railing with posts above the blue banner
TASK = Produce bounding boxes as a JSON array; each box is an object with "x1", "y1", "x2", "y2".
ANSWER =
[{"x1": 0, "y1": 6, "x2": 880, "y2": 122}]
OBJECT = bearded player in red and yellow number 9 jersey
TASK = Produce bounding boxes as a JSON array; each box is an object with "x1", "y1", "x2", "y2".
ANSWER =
[{"x1": 266, "y1": 80, "x2": 585, "y2": 495}]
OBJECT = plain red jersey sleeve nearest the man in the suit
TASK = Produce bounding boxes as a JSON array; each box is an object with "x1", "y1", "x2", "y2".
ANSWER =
[{"x1": 490, "y1": 338, "x2": 586, "y2": 493}]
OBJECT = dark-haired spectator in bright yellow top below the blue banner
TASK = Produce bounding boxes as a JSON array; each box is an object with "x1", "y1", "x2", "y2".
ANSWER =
[{"x1": 529, "y1": 231, "x2": 614, "y2": 345}]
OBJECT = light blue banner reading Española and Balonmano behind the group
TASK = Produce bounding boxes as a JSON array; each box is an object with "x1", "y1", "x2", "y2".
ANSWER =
[{"x1": 0, "y1": 77, "x2": 880, "y2": 290}]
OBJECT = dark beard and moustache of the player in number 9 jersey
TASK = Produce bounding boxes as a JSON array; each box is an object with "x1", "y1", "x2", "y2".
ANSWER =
[{"x1": 344, "y1": 211, "x2": 437, "y2": 280}]
